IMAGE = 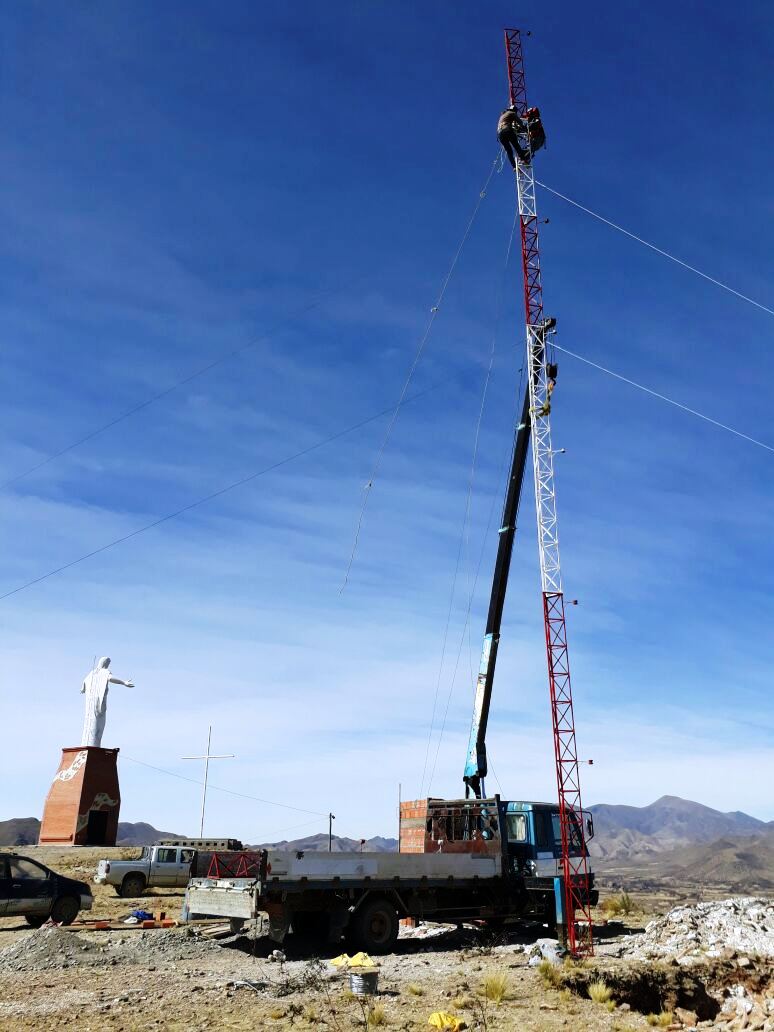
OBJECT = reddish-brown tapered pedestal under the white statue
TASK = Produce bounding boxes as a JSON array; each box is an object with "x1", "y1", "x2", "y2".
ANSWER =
[{"x1": 38, "y1": 745, "x2": 121, "y2": 845}]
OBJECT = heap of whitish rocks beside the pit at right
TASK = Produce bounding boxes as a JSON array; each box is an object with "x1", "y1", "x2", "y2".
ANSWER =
[{"x1": 623, "y1": 896, "x2": 774, "y2": 958}]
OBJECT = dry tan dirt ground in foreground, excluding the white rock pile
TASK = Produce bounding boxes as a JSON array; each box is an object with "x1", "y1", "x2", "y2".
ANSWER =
[{"x1": 0, "y1": 848, "x2": 774, "y2": 1032}]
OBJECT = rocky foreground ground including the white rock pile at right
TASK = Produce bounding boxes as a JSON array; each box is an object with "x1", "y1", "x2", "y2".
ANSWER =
[{"x1": 0, "y1": 850, "x2": 774, "y2": 1032}]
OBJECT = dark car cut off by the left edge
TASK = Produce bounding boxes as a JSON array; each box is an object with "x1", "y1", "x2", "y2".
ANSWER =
[{"x1": 0, "y1": 852, "x2": 94, "y2": 928}]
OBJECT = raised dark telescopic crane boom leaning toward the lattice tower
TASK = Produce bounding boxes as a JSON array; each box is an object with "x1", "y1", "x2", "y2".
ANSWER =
[{"x1": 463, "y1": 387, "x2": 530, "y2": 799}]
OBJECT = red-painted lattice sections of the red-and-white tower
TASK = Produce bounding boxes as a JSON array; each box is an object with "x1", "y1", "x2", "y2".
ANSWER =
[{"x1": 505, "y1": 29, "x2": 593, "y2": 956}]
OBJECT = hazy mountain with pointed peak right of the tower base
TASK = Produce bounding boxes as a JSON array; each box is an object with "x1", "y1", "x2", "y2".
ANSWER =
[{"x1": 588, "y1": 796, "x2": 772, "y2": 861}]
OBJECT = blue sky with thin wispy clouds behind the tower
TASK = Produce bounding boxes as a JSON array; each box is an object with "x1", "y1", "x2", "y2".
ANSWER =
[{"x1": 0, "y1": 2, "x2": 774, "y2": 840}]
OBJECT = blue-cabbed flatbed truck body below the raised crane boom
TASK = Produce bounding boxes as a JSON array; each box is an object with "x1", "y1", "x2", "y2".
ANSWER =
[{"x1": 184, "y1": 797, "x2": 599, "y2": 954}]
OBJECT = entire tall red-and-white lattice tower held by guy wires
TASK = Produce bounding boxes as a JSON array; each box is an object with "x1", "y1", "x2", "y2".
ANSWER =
[{"x1": 505, "y1": 29, "x2": 593, "y2": 955}]
